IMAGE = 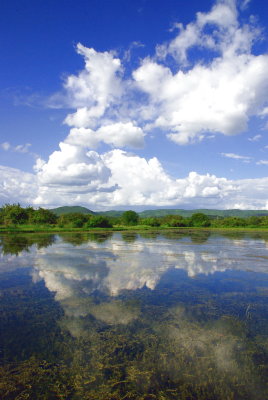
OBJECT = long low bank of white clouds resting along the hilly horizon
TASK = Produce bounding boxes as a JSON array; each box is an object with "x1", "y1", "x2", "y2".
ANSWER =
[{"x1": 0, "y1": 147, "x2": 268, "y2": 210}]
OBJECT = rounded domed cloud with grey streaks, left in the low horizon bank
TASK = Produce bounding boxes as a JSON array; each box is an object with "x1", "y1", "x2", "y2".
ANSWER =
[{"x1": 34, "y1": 142, "x2": 116, "y2": 204}]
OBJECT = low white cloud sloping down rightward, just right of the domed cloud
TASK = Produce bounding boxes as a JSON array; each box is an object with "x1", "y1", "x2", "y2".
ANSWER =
[{"x1": 103, "y1": 150, "x2": 236, "y2": 206}]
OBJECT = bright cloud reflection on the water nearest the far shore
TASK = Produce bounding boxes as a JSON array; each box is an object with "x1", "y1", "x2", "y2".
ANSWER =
[{"x1": 31, "y1": 234, "x2": 267, "y2": 300}]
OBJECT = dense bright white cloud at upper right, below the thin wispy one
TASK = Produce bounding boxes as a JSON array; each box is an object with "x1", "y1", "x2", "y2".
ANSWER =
[{"x1": 133, "y1": 46, "x2": 268, "y2": 144}]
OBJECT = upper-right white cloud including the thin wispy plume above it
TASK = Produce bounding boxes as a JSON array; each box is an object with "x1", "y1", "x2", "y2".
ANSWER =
[{"x1": 133, "y1": 1, "x2": 268, "y2": 144}]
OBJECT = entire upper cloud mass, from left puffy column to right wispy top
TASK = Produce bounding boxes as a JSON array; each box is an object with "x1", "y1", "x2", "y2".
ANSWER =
[{"x1": 43, "y1": 0, "x2": 268, "y2": 147}]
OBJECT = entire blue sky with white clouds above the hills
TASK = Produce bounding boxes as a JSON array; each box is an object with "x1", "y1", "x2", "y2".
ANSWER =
[{"x1": 0, "y1": 0, "x2": 268, "y2": 211}]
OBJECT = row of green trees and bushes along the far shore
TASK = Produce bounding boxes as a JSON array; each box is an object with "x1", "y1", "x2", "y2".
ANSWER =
[{"x1": 0, "y1": 204, "x2": 268, "y2": 229}]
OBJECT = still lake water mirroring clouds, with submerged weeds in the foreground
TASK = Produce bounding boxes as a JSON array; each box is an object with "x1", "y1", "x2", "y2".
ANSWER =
[{"x1": 0, "y1": 232, "x2": 268, "y2": 400}]
